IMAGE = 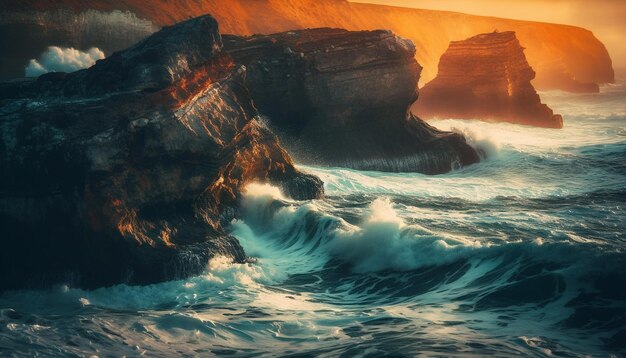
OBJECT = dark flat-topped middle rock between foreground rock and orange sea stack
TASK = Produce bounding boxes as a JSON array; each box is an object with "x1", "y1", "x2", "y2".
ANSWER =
[{"x1": 224, "y1": 29, "x2": 478, "y2": 174}]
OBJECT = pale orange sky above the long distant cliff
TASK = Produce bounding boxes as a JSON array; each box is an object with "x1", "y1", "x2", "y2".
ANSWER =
[{"x1": 351, "y1": 0, "x2": 626, "y2": 67}]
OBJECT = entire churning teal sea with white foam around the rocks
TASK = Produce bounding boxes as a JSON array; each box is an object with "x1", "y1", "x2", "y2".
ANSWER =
[{"x1": 0, "y1": 76, "x2": 626, "y2": 357}]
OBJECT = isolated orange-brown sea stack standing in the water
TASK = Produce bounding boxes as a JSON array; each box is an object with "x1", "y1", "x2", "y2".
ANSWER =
[{"x1": 416, "y1": 31, "x2": 563, "y2": 128}]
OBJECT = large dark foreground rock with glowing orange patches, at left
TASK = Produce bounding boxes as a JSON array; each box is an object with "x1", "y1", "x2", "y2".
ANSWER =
[{"x1": 0, "y1": 16, "x2": 323, "y2": 290}]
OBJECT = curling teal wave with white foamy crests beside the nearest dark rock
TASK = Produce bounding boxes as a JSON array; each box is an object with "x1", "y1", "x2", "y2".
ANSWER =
[{"x1": 232, "y1": 185, "x2": 488, "y2": 274}]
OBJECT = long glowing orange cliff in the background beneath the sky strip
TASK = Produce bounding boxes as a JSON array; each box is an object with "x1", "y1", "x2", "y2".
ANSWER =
[{"x1": 0, "y1": 0, "x2": 614, "y2": 91}]
